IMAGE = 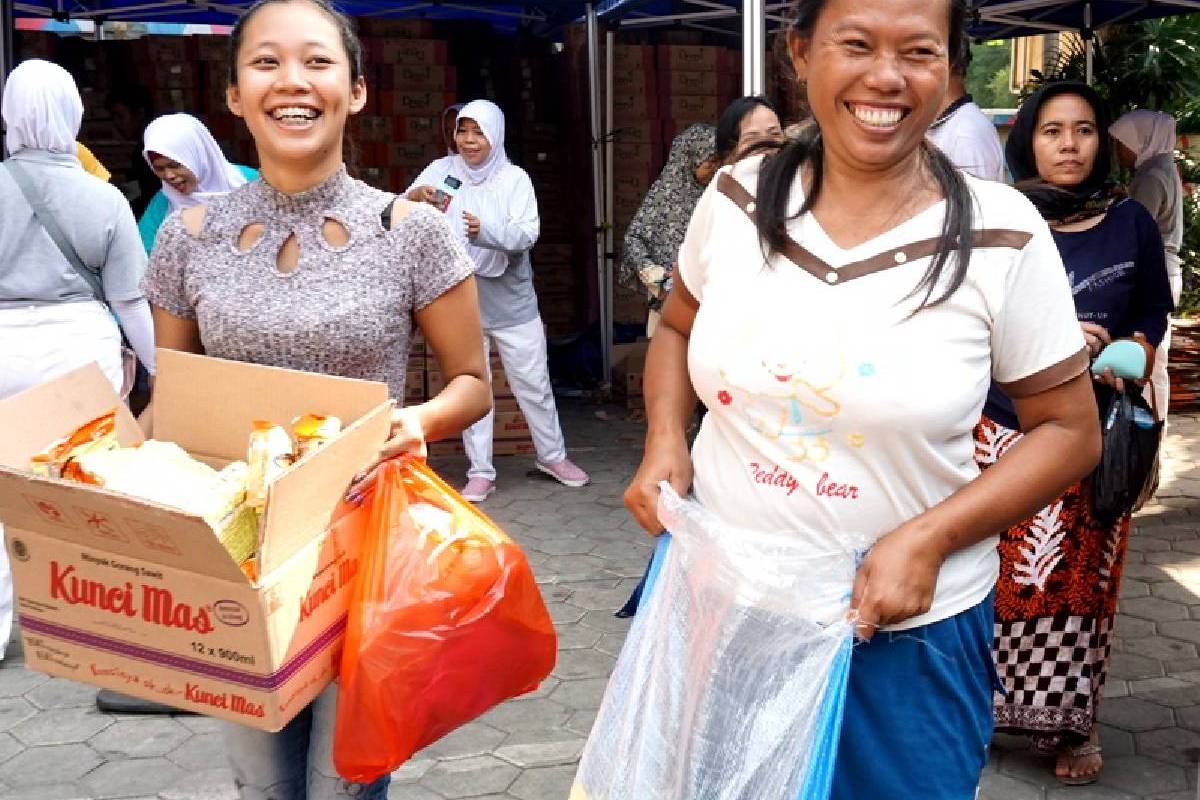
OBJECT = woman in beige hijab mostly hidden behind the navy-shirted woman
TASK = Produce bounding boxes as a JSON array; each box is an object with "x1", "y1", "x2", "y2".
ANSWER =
[{"x1": 1109, "y1": 109, "x2": 1183, "y2": 420}]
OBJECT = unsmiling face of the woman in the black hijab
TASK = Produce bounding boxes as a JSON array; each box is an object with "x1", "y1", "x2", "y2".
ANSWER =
[{"x1": 1033, "y1": 95, "x2": 1100, "y2": 187}]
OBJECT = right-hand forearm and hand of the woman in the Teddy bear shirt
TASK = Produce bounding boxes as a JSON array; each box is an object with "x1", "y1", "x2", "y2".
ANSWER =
[{"x1": 851, "y1": 373, "x2": 1100, "y2": 638}]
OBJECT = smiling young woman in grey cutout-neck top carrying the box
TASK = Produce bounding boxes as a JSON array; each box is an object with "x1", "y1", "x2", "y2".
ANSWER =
[{"x1": 145, "y1": 0, "x2": 491, "y2": 800}]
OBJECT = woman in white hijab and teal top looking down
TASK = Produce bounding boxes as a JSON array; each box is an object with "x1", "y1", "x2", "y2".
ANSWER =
[{"x1": 138, "y1": 114, "x2": 258, "y2": 253}]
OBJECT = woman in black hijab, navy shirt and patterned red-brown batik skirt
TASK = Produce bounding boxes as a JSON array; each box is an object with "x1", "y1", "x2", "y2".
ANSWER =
[{"x1": 976, "y1": 83, "x2": 1172, "y2": 784}]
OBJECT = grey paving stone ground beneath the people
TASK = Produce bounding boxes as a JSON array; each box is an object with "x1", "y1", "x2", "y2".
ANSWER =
[{"x1": 0, "y1": 403, "x2": 1200, "y2": 800}]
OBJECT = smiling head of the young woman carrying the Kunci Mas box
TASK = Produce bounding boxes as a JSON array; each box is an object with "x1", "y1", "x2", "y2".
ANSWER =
[{"x1": 228, "y1": 0, "x2": 366, "y2": 178}]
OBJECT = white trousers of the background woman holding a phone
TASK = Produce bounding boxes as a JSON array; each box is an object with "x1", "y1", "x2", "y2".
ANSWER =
[{"x1": 462, "y1": 317, "x2": 566, "y2": 481}]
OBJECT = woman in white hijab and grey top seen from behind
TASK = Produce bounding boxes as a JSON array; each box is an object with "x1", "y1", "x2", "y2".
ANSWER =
[{"x1": 0, "y1": 59, "x2": 154, "y2": 655}]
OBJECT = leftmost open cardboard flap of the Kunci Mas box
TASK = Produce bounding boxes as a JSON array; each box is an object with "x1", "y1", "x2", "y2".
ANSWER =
[{"x1": 0, "y1": 363, "x2": 143, "y2": 471}]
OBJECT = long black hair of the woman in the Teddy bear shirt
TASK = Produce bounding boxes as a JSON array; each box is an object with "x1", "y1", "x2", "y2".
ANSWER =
[{"x1": 757, "y1": 0, "x2": 973, "y2": 311}]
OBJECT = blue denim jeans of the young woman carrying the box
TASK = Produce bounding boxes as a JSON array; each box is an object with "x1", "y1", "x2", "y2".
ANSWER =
[{"x1": 224, "y1": 684, "x2": 391, "y2": 800}]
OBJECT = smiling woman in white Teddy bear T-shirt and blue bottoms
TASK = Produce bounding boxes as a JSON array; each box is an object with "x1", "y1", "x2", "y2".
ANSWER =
[{"x1": 625, "y1": 0, "x2": 1099, "y2": 800}]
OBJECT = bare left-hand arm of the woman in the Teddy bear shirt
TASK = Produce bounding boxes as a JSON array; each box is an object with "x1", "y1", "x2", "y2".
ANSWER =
[{"x1": 625, "y1": 281, "x2": 700, "y2": 536}]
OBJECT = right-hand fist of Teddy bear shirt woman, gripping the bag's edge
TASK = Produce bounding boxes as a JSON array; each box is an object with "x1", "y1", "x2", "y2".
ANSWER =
[{"x1": 850, "y1": 518, "x2": 946, "y2": 640}]
